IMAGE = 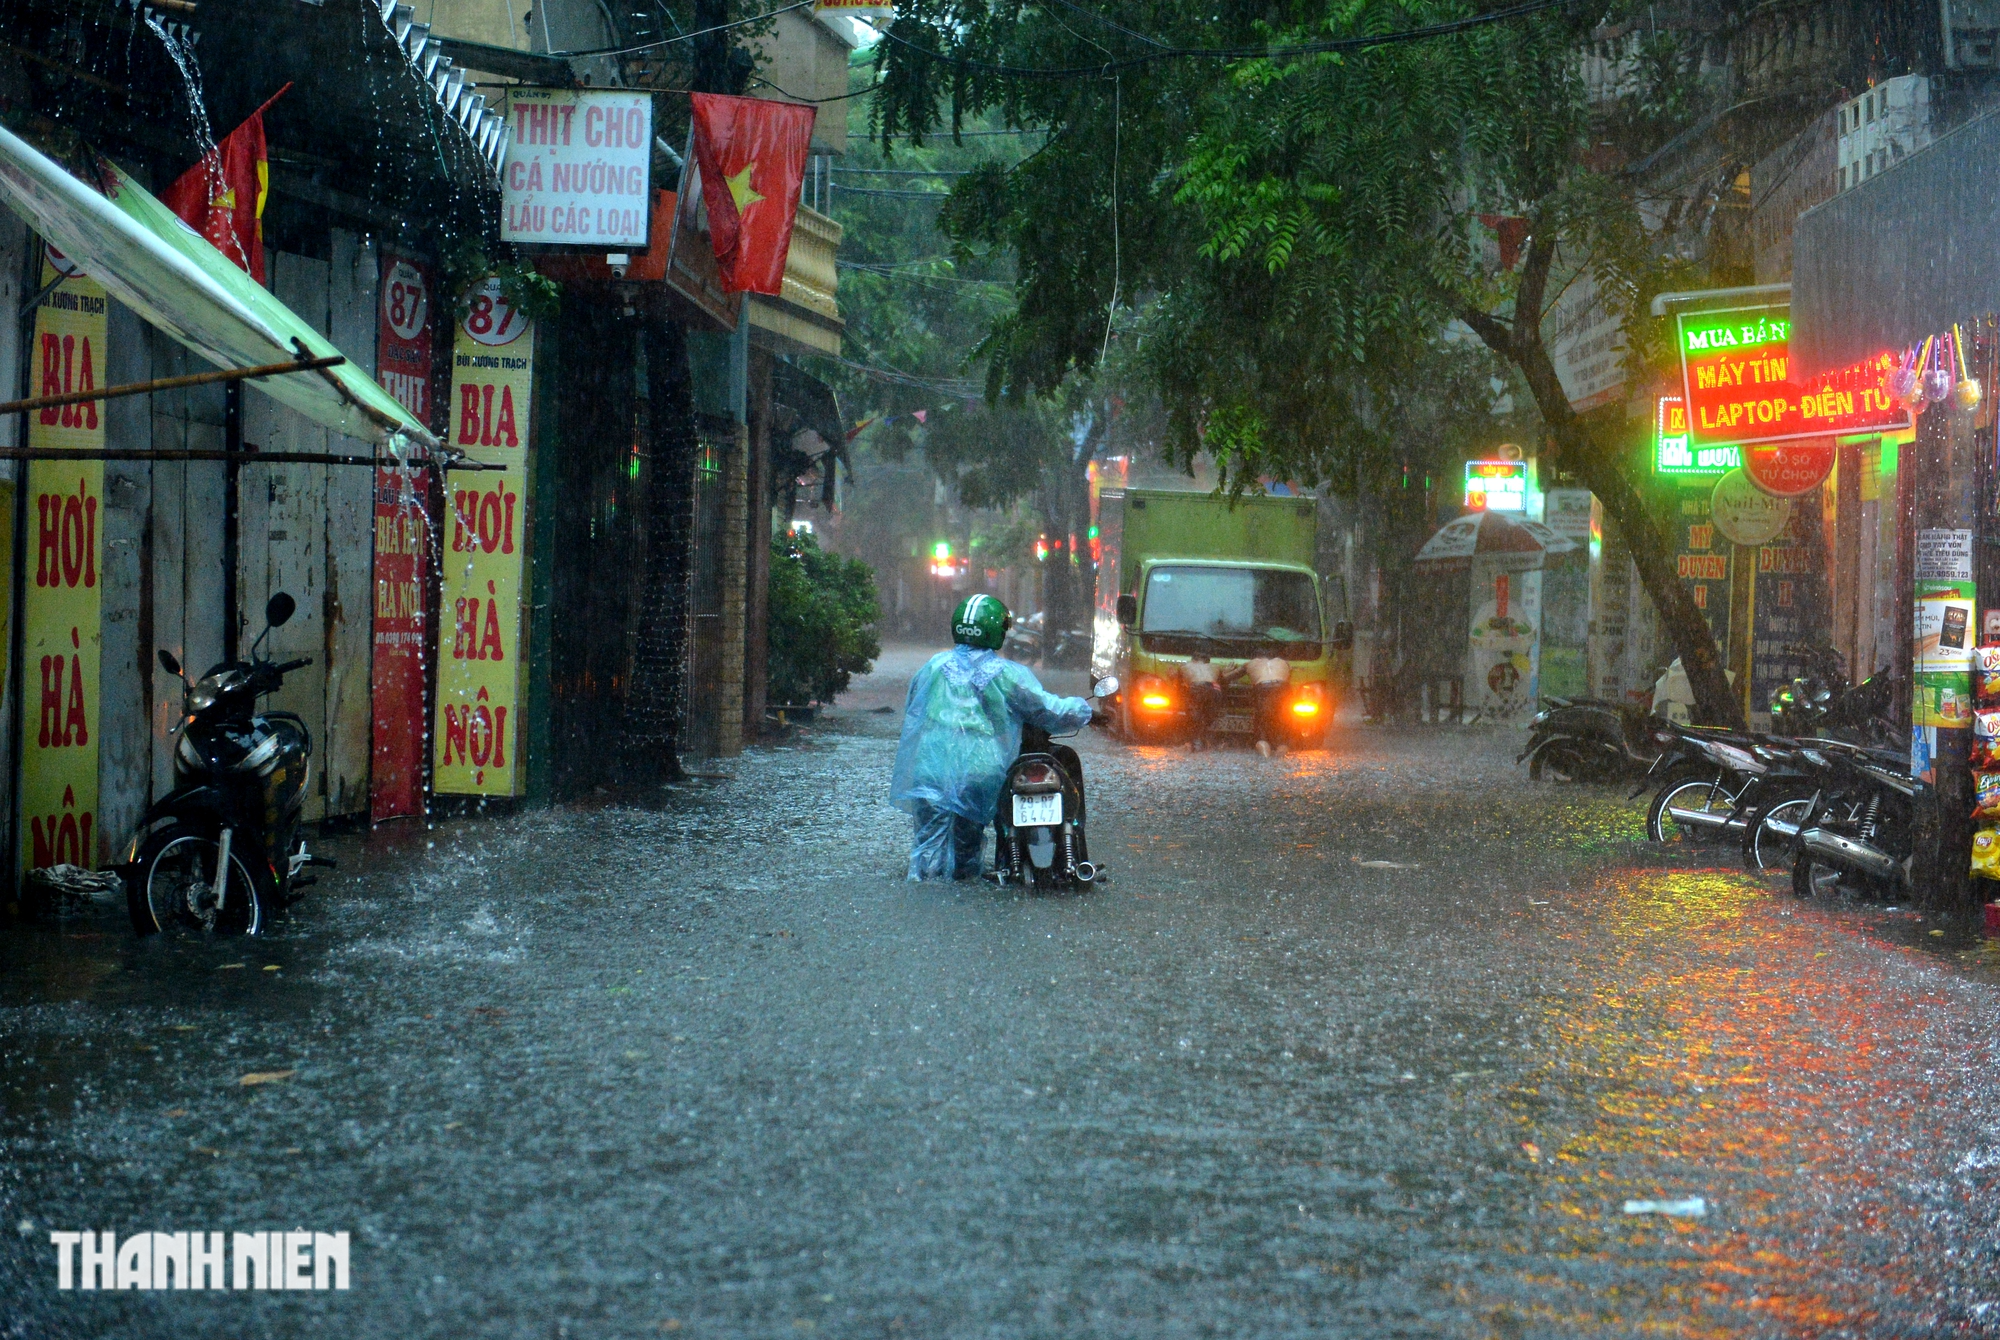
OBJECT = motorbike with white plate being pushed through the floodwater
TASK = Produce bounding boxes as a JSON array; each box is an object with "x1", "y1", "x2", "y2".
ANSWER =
[{"x1": 994, "y1": 676, "x2": 1118, "y2": 888}]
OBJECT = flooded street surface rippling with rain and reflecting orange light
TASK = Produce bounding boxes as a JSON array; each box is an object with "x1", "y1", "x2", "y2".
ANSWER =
[{"x1": 0, "y1": 656, "x2": 2000, "y2": 1340}]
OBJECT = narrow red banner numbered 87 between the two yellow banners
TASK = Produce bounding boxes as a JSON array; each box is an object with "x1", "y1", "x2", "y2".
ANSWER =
[{"x1": 368, "y1": 252, "x2": 434, "y2": 824}]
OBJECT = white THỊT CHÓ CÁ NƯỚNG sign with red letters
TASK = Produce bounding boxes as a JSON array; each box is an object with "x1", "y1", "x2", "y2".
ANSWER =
[{"x1": 500, "y1": 88, "x2": 652, "y2": 250}]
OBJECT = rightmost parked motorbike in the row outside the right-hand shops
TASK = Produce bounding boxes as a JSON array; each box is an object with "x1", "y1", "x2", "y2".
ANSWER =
[{"x1": 1792, "y1": 742, "x2": 1916, "y2": 898}]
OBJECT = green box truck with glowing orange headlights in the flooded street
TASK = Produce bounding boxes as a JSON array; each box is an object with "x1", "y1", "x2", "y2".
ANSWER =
[{"x1": 1092, "y1": 488, "x2": 1354, "y2": 746}]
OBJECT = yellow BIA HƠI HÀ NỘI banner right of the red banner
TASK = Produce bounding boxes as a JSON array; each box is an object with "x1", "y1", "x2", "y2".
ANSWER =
[{"x1": 432, "y1": 280, "x2": 534, "y2": 796}]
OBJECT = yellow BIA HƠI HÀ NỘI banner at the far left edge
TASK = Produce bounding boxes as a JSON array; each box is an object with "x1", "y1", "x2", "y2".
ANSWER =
[{"x1": 20, "y1": 256, "x2": 106, "y2": 870}]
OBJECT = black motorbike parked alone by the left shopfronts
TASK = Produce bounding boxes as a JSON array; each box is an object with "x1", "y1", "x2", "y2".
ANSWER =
[{"x1": 120, "y1": 592, "x2": 334, "y2": 936}]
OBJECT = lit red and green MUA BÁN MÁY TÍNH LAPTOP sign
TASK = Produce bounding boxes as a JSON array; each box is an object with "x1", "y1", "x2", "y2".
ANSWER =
[{"x1": 1676, "y1": 304, "x2": 1910, "y2": 452}]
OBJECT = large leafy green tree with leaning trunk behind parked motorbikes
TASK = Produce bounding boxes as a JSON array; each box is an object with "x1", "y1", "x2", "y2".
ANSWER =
[{"x1": 876, "y1": 0, "x2": 1742, "y2": 724}]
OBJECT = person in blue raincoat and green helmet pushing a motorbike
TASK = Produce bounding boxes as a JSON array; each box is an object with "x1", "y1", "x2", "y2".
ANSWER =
[{"x1": 890, "y1": 596, "x2": 1090, "y2": 880}]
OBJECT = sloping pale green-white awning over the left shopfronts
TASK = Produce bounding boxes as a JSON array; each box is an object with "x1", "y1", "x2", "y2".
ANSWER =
[{"x1": 0, "y1": 126, "x2": 438, "y2": 450}]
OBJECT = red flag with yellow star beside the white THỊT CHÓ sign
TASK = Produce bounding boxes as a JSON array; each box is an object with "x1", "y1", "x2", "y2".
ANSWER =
[{"x1": 694, "y1": 94, "x2": 816, "y2": 294}]
